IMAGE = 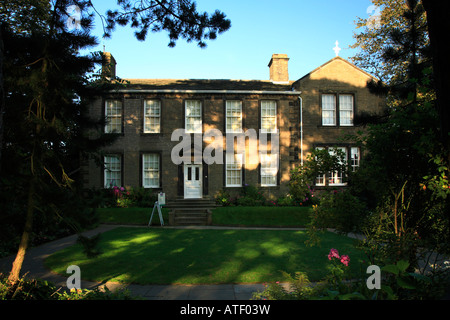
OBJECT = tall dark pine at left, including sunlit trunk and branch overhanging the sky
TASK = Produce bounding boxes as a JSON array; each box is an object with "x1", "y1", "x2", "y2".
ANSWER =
[{"x1": 0, "y1": 0, "x2": 230, "y2": 283}]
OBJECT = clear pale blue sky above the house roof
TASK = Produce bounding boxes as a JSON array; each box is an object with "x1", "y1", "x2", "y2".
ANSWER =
[{"x1": 86, "y1": 0, "x2": 372, "y2": 80}]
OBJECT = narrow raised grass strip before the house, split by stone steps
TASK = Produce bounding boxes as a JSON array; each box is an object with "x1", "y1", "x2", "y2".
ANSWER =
[{"x1": 97, "y1": 207, "x2": 312, "y2": 227}]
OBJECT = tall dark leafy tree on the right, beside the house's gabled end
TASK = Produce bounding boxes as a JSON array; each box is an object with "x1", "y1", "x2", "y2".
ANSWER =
[{"x1": 352, "y1": 0, "x2": 449, "y2": 265}]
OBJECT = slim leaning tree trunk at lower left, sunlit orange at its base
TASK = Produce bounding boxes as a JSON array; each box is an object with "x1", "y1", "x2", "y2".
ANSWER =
[{"x1": 8, "y1": 178, "x2": 35, "y2": 283}]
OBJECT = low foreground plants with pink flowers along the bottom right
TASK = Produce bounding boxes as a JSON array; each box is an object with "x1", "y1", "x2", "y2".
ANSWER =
[{"x1": 253, "y1": 249, "x2": 448, "y2": 300}]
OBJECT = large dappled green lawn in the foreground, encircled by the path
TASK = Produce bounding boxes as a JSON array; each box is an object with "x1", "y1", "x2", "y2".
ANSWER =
[{"x1": 45, "y1": 227, "x2": 362, "y2": 284}]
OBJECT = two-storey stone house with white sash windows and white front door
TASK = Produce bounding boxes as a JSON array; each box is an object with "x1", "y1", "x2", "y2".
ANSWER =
[{"x1": 83, "y1": 53, "x2": 383, "y2": 206}]
